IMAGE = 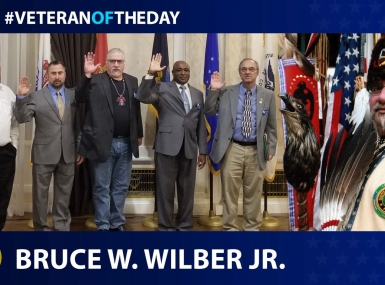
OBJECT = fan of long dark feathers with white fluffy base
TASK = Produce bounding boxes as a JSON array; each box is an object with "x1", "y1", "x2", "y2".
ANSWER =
[{"x1": 320, "y1": 121, "x2": 377, "y2": 231}]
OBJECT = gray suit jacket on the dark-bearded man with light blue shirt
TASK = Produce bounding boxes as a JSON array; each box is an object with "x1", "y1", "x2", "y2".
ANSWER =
[{"x1": 15, "y1": 87, "x2": 77, "y2": 164}]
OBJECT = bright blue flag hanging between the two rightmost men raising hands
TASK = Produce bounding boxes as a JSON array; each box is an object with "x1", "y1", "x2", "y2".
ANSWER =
[{"x1": 203, "y1": 34, "x2": 220, "y2": 175}]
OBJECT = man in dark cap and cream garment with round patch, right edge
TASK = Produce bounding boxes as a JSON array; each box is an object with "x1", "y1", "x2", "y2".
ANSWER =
[{"x1": 338, "y1": 38, "x2": 385, "y2": 231}]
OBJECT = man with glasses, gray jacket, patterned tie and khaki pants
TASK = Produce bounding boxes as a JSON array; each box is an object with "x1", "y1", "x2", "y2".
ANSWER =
[{"x1": 205, "y1": 58, "x2": 277, "y2": 231}]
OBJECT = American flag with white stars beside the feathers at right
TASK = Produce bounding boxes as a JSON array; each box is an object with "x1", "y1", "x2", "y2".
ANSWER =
[{"x1": 325, "y1": 34, "x2": 361, "y2": 138}]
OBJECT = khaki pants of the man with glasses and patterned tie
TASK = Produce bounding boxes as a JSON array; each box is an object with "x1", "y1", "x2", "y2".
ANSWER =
[{"x1": 221, "y1": 142, "x2": 264, "y2": 231}]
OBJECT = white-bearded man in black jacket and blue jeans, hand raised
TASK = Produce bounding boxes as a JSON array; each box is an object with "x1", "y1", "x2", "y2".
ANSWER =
[{"x1": 75, "y1": 48, "x2": 143, "y2": 231}]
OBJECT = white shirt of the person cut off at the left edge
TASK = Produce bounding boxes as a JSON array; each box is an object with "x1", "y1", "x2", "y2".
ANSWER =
[{"x1": 0, "y1": 83, "x2": 19, "y2": 148}]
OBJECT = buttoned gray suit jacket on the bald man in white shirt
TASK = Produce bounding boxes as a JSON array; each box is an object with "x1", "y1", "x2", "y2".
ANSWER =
[{"x1": 136, "y1": 78, "x2": 207, "y2": 159}]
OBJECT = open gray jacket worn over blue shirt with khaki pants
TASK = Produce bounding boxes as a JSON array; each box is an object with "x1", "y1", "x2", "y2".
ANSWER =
[{"x1": 205, "y1": 84, "x2": 277, "y2": 170}]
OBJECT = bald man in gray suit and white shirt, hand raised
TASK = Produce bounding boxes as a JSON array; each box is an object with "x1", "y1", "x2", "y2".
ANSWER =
[{"x1": 137, "y1": 54, "x2": 207, "y2": 231}]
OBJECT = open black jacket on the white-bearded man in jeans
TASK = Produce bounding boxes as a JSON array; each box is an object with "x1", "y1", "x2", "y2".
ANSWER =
[{"x1": 75, "y1": 73, "x2": 143, "y2": 162}]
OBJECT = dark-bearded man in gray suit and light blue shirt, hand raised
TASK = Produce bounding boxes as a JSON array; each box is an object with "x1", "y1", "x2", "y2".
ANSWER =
[{"x1": 15, "y1": 61, "x2": 83, "y2": 231}]
